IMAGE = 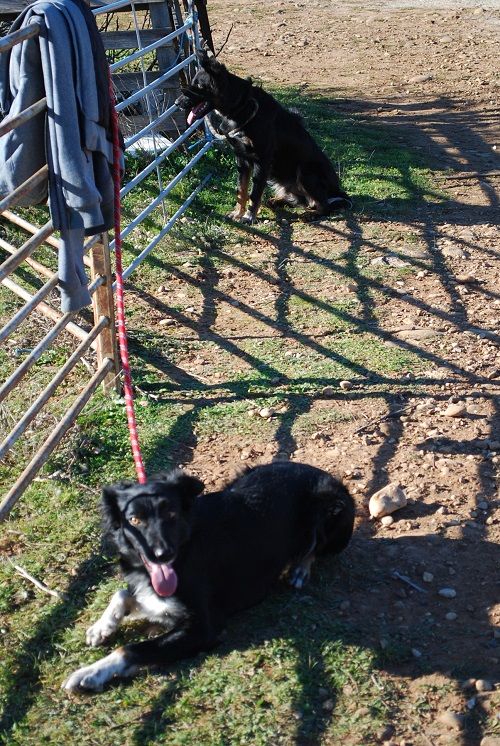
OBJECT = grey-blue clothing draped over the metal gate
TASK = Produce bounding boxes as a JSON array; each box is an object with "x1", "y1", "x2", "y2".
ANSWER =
[{"x1": 0, "y1": 0, "x2": 122, "y2": 312}]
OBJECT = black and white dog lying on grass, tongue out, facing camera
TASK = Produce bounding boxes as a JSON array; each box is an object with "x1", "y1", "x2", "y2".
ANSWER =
[{"x1": 63, "y1": 462, "x2": 354, "y2": 691}]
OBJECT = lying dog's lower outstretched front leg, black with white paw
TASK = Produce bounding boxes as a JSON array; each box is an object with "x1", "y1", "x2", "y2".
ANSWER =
[{"x1": 62, "y1": 623, "x2": 218, "y2": 692}]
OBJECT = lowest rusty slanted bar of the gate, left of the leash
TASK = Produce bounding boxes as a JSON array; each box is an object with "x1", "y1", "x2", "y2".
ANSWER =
[{"x1": 0, "y1": 359, "x2": 114, "y2": 521}]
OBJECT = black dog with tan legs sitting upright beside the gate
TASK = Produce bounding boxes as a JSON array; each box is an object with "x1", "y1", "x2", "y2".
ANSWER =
[{"x1": 176, "y1": 51, "x2": 351, "y2": 223}]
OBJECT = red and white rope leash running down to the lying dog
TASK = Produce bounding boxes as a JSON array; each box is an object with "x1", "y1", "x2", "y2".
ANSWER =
[{"x1": 109, "y1": 74, "x2": 146, "y2": 484}]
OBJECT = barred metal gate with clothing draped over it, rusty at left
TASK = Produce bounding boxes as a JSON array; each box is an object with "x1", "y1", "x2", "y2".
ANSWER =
[{"x1": 0, "y1": 0, "x2": 212, "y2": 520}]
